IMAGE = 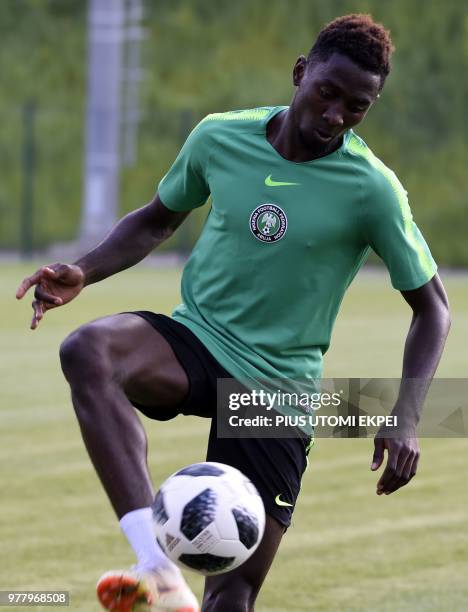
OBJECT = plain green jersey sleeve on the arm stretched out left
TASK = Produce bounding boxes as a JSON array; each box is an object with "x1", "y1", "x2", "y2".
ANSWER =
[{"x1": 158, "y1": 121, "x2": 210, "y2": 211}]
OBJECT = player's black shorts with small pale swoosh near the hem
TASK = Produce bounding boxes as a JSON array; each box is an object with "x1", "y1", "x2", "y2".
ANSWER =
[{"x1": 132, "y1": 311, "x2": 309, "y2": 527}]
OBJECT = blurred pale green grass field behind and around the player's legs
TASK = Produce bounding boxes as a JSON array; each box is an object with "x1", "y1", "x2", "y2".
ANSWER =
[{"x1": 0, "y1": 265, "x2": 468, "y2": 612}]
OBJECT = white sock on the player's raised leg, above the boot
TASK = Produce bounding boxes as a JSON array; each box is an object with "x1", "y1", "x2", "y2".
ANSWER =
[{"x1": 120, "y1": 508, "x2": 172, "y2": 571}]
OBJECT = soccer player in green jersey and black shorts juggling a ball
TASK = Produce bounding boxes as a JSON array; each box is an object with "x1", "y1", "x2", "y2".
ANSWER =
[{"x1": 17, "y1": 15, "x2": 450, "y2": 612}]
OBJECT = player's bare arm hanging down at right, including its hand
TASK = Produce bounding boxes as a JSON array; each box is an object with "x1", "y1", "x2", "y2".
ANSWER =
[{"x1": 371, "y1": 274, "x2": 450, "y2": 495}]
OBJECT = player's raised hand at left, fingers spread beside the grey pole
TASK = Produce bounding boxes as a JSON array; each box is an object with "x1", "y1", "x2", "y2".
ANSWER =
[{"x1": 16, "y1": 263, "x2": 85, "y2": 329}]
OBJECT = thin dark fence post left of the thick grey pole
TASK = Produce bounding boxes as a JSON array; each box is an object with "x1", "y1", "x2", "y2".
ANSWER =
[{"x1": 20, "y1": 101, "x2": 36, "y2": 259}]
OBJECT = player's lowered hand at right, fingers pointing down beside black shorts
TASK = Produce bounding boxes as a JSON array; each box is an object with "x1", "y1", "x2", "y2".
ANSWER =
[{"x1": 371, "y1": 435, "x2": 420, "y2": 495}]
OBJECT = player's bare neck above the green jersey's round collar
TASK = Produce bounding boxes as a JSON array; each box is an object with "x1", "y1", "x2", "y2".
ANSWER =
[{"x1": 266, "y1": 107, "x2": 343, "y2": 162}]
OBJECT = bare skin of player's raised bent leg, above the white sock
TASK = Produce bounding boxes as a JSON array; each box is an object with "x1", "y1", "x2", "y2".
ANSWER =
[{"x1": 60, "y1": 314, "x2": 189, "y2": 519}]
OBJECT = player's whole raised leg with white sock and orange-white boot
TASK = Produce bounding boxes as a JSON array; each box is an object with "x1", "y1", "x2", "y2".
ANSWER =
[{"x1": 60, "y1": 314, "x2": 199, "y2": 612}]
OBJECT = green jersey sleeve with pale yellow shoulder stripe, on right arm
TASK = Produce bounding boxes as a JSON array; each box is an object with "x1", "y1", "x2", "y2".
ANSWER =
[{"x1": 365, "y1": 164, "x2": 437, "y2": 291}]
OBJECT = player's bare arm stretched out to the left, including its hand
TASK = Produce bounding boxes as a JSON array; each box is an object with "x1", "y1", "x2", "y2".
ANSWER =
[{"x1": 16, "y1": 195, "x2": 189, "y2": 329}]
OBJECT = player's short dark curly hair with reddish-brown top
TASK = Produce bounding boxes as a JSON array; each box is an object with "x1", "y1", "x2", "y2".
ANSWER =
[{"x1": 307, "y1": 14, "x2": 395, "y2": 89}]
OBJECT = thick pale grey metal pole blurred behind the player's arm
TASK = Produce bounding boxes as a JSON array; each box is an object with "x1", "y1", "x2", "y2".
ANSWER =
[{"x1": 80, "y1": 0, "x2": 125, "y2": 247}]
